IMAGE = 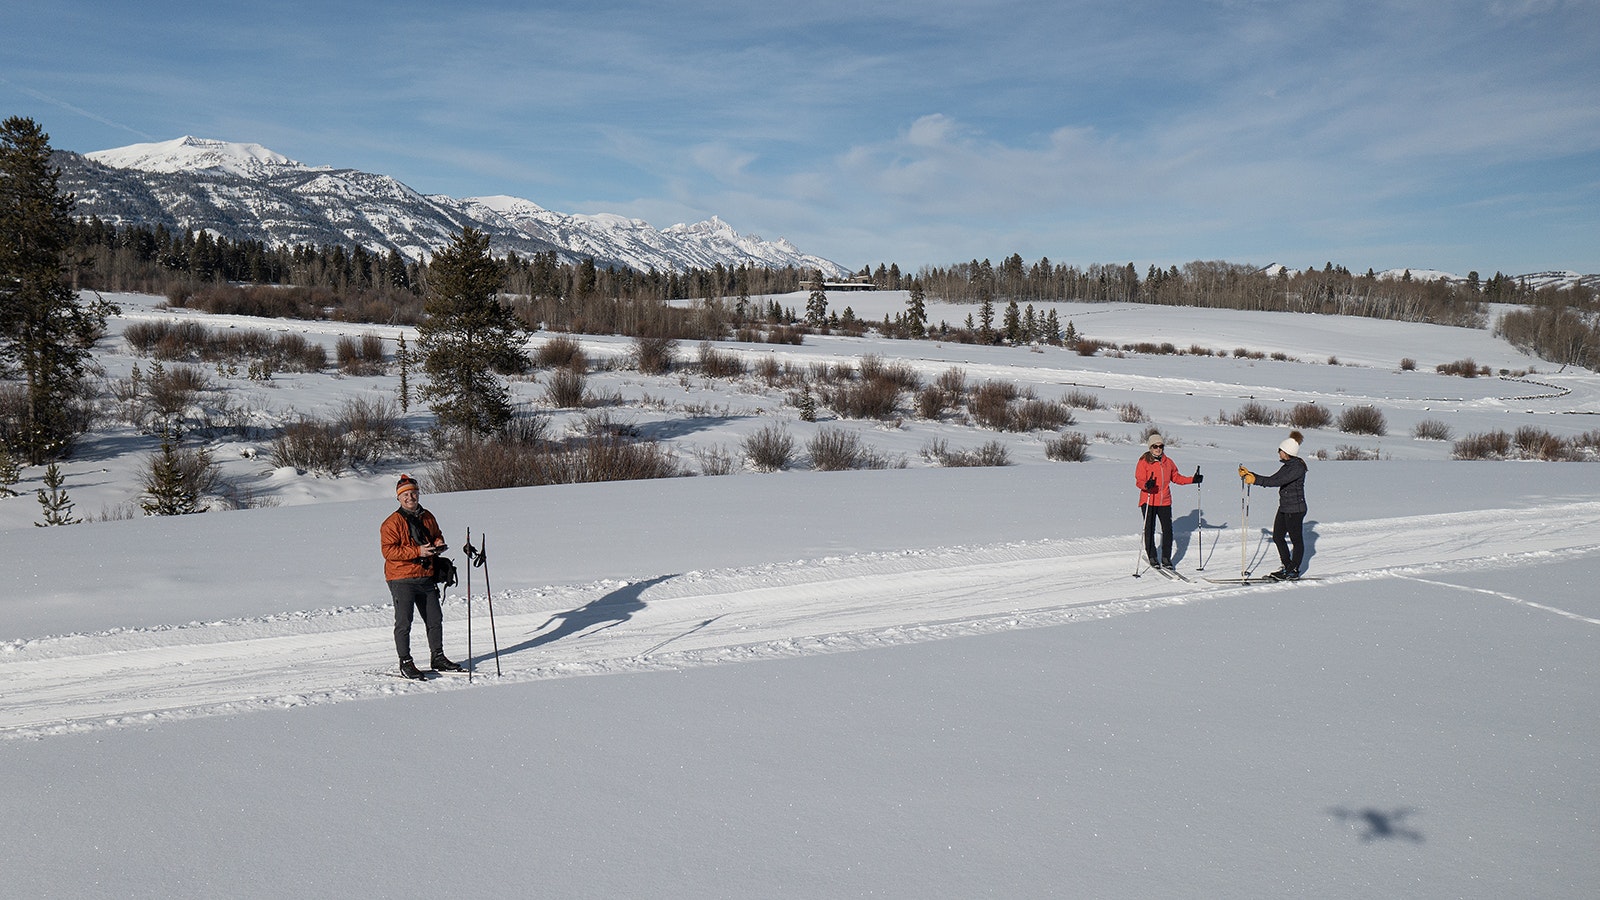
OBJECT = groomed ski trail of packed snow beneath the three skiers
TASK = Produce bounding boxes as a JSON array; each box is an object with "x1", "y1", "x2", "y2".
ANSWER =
[{"x1": 0, "y1": 503, "x2": 1600, "y2": 738}]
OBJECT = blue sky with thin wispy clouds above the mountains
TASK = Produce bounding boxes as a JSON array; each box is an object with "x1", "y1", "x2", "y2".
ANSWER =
[{"x1": 0, "y1": 0, "x2": 1600, "y2": 277}]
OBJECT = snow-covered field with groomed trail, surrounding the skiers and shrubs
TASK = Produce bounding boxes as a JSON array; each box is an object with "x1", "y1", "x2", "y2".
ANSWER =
[{"x1": 0, "y1": 293, "x2": 1600, "y2": 898}]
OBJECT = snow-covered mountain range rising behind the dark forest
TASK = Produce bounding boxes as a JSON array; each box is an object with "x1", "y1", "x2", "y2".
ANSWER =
[{"x1": 56, "y1": 138, "x2": 846, "y2": 277}]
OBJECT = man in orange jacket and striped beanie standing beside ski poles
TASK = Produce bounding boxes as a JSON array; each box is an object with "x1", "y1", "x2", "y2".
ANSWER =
[{"x1": 378, "y1": 476, "x2": 461, "y2": 679}]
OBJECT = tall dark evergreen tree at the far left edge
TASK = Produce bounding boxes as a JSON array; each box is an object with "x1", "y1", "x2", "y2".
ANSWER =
[{"x1": 0, "y1": 117, "x2": 115, "y2": 464}]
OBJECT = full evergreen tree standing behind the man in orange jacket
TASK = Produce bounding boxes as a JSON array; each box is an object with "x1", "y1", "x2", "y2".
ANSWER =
[{"x1": 418, "y1": 227, "x2": 530, "y2": 436}]
